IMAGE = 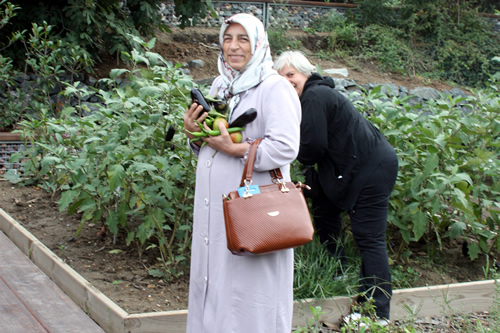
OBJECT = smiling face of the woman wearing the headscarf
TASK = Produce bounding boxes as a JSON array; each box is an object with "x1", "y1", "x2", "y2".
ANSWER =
[{"x1": 222, "y1": 23, "x2": 252, "y2": 71}]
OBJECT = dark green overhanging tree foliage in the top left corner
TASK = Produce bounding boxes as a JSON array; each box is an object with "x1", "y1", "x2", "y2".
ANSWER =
[{"x1": 0, "y1": 0, "x2": 166, "y2": 69}]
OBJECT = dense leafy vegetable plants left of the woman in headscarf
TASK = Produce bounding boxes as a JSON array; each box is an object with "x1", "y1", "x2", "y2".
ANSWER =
[{"x1": 12, "y1": 40, "x2": 199, "y2": 279}]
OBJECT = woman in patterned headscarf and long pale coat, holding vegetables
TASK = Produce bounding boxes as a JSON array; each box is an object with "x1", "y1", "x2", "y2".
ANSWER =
[{"x1": 184, "y1": 14, "x2": 301, "y2": 333}]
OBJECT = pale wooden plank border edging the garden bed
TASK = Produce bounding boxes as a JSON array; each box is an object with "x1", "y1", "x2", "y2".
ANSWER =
[{"x1": 0, "y1": 209, "x2": 496, "y2": 333}]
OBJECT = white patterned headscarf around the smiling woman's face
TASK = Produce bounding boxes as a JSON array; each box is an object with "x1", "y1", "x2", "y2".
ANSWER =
[{"x1": 218, "y1": 13, "x2": 277, "y2": 120}]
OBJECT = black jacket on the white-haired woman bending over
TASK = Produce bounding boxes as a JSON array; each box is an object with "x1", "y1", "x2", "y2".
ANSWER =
[{"x1": 298, "y1": 73, "x2": 394, "y2": 210}]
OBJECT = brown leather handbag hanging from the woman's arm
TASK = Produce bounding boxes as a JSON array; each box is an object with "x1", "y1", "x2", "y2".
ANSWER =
[{"x1": 222, "y1": 139, "x2": 314, "y2": 255}]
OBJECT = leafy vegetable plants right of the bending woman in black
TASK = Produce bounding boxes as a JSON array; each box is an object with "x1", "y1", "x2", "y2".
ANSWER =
[{"x1": 356, "y1": 83, "x2": 500, "y2": 259}]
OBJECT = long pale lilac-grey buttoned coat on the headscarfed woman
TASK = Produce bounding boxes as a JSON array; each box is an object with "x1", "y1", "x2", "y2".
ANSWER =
[{"x1": 187, "y1": 74, "x2": 301, "y2": 333}]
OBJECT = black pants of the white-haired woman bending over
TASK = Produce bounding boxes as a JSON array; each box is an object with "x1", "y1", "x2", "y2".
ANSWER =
[{"x1": 312, "y1": 153, "x2": 398, "y2": 319}]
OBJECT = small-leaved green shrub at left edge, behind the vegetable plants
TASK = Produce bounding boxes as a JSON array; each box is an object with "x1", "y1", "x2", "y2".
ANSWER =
[{"x1": 0, "y1": 18, "x2": 94, "y2": 129}]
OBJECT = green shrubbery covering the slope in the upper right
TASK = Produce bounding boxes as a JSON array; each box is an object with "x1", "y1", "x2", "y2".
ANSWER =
[{"x1": 320, "y1": 0, "x2": 500, "y2": 87}]
